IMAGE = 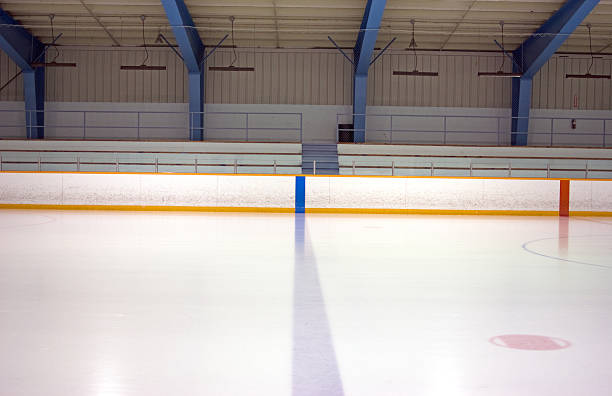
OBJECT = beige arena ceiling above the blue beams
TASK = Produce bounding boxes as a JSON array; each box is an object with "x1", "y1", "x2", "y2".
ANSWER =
[{"x1": 0, "y1": 0, "x2": 612, "y2": 52}]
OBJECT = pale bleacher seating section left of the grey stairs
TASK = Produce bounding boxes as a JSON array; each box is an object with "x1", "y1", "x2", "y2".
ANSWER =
[{"x1": 0, "y1": 140, "x2": 302, "y2": 174}]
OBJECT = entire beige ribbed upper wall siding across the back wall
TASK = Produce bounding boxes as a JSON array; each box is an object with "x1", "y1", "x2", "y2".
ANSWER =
[{"x1": 0, "y1": 48, "x2": 612, "y2": 110}]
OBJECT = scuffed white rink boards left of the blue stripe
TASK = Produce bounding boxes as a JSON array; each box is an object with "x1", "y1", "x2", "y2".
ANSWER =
[{"x1": 0, "y1": 172, "x2": 295, "y2": 208}]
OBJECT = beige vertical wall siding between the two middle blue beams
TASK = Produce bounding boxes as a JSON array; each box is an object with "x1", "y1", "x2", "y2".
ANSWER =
[{"x1": 206, "y1": 49, "x2": 353, "y2": 105}]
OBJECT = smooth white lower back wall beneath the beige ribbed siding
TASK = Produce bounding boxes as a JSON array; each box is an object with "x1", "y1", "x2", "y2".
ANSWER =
[{"x1": 0, "y1": 102, "x2": 612, "y2": 147}]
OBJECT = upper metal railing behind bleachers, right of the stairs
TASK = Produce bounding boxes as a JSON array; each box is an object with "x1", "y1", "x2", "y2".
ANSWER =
[{"x1": 336, "y1": 113, "x2": 612, "y2": 147}]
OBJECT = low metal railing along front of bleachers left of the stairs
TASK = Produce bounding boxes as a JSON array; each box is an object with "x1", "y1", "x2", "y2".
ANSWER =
[{"x1": 0, "y1": 156, "x2": 301, "y2": 174}]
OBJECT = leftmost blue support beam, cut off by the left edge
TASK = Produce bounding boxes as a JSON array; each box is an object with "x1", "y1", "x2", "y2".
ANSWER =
[{"x1": 0, "y1": 8, "x2": 45, "y2": 139}]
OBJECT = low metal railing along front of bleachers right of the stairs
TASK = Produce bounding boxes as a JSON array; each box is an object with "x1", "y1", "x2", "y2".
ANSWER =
[{"x1": 340, "y1": 161, "x2": 612, "y2": 179}]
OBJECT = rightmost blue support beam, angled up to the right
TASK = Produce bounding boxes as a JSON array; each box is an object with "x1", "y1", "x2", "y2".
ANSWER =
[{"x1": 511, "y1": 0, "x2": 599, "y2": 146}]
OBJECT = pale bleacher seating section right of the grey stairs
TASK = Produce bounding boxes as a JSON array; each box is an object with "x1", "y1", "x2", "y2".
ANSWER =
[{"x1": 338, "y1": 144, "x2": 612, "y2": 178}]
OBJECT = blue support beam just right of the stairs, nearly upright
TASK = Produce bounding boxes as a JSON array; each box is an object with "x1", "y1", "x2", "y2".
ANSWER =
[{"x1": 353, "y1": 0, "x2": 387, "y2": 143}]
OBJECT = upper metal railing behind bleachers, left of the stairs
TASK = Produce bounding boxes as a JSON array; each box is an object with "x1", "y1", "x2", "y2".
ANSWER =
[{"x1": 0, "y1": 110, "x2": 302, "y2": 142}]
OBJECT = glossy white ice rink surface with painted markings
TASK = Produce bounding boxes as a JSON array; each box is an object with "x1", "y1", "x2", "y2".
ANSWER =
[{"x1": 0, "y1": 210, "x2": 612, "y2": 396}]
